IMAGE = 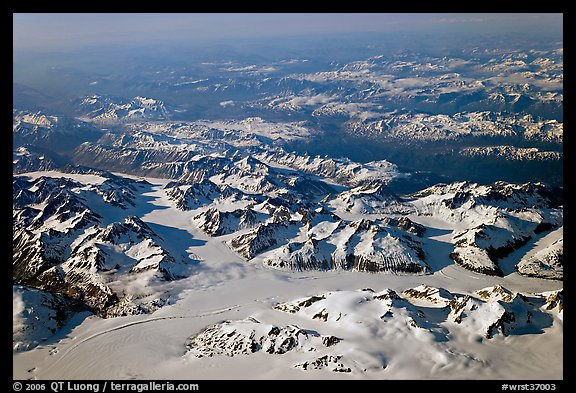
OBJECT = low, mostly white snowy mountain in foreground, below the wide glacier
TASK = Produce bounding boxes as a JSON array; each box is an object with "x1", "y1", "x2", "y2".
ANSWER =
[{"x1": 185, "y1": 285, "x2": 561, "y2": 376}]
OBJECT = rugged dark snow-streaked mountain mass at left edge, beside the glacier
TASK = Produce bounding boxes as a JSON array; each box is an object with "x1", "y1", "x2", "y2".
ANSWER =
[{"x1": 13, "y1": 174, "x2": 194, "y2": 316}]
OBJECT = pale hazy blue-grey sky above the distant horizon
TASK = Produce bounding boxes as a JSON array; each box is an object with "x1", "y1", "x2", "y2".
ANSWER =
[{"x1": 13, "y1": 13, "x2": 563, "y2": 50}]
